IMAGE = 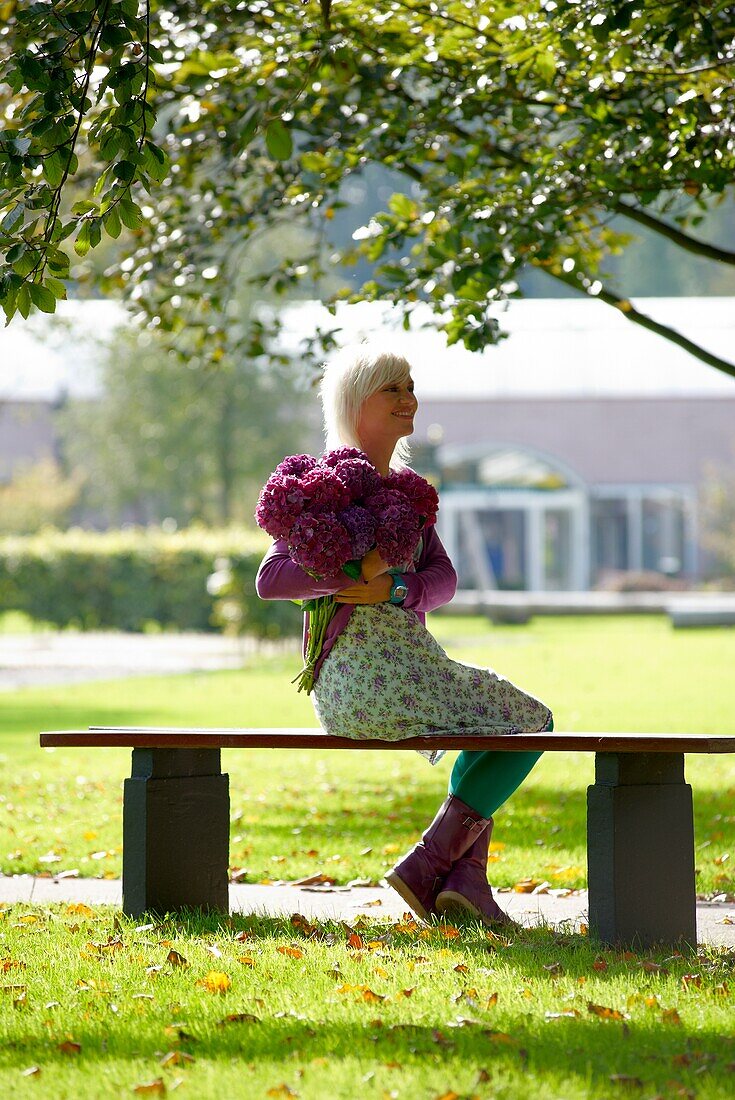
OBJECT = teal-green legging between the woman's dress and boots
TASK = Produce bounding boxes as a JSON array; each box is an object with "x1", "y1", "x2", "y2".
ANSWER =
[{"x1": 449, "y1": 718, "x2": 553, "y2": 817}]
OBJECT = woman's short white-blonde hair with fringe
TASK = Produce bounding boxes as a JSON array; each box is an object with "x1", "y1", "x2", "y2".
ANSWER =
[{"x1": 319, "y1": 343, "x2": 410, "y2": 468}]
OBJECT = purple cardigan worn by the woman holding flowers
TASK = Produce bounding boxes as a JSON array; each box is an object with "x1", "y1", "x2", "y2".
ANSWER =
[{"x1": 255, "y1": 527, "x2": 457, "y2": 680}]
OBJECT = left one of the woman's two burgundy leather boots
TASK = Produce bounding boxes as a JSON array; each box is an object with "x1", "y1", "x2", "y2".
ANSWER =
[{"x1": 385, "y1": 794, "x2": 487, "y2": 922}]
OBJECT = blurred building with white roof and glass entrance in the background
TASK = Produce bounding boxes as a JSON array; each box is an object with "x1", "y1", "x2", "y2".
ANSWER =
[{"x1": 0, "y1": 298, "x2": 735, "y2": 591}]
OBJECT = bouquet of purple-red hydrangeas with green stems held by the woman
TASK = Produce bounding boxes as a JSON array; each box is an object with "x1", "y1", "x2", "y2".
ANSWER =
[{"x1": 255, "y1": 447, "x2": 439, "y2": 694}]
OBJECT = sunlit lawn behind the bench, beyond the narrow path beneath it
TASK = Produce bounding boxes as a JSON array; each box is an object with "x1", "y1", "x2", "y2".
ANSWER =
[{"x1": 0, "y1": 616, "x2": 735, "y2": 894}]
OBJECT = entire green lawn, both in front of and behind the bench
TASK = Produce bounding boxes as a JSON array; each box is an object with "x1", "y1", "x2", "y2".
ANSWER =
[{"x1": 0, "y1": 617, "x2": 735, "y2": 1100}]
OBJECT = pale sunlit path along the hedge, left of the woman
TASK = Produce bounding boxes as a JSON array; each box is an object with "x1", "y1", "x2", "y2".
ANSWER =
[{"x1": 0, "y1": 630, "x2": 297, "y2": 691}]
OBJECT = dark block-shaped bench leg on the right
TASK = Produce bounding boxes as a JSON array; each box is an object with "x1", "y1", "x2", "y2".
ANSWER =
[{"x1": 588, "y1": 752, "x2": 696, "y2": 947}]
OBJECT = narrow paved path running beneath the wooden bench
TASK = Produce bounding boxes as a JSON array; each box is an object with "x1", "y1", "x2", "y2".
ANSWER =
[{"x1": 0, "y1": 875, "x2": 735, "y2": 948}]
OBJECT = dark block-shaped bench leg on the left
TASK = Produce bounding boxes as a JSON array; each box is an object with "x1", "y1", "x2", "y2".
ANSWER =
[{"x1": 122, "y1": 749, "x2": 230, "y2": 916}]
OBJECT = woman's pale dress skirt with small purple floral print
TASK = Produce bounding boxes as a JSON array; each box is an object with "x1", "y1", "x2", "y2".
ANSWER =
[{"x1": 311, "y1": 550, "x2": 551, "y2": 763}]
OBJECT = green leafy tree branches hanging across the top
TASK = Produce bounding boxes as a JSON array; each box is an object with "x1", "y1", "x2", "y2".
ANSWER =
[{"x1": 0, "y1": 0, "x2": 735, "y2": 374}]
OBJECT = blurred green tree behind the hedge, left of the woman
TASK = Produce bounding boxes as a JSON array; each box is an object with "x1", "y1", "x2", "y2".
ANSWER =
[{"x1": 58, "y1": 224, "x2": 318, "y2": 526}]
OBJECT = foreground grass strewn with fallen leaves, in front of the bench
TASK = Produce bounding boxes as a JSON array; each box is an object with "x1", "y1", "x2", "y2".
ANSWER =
[{"x1": 0, "y1": 904, "x2": 735, "y2": 1100}]
